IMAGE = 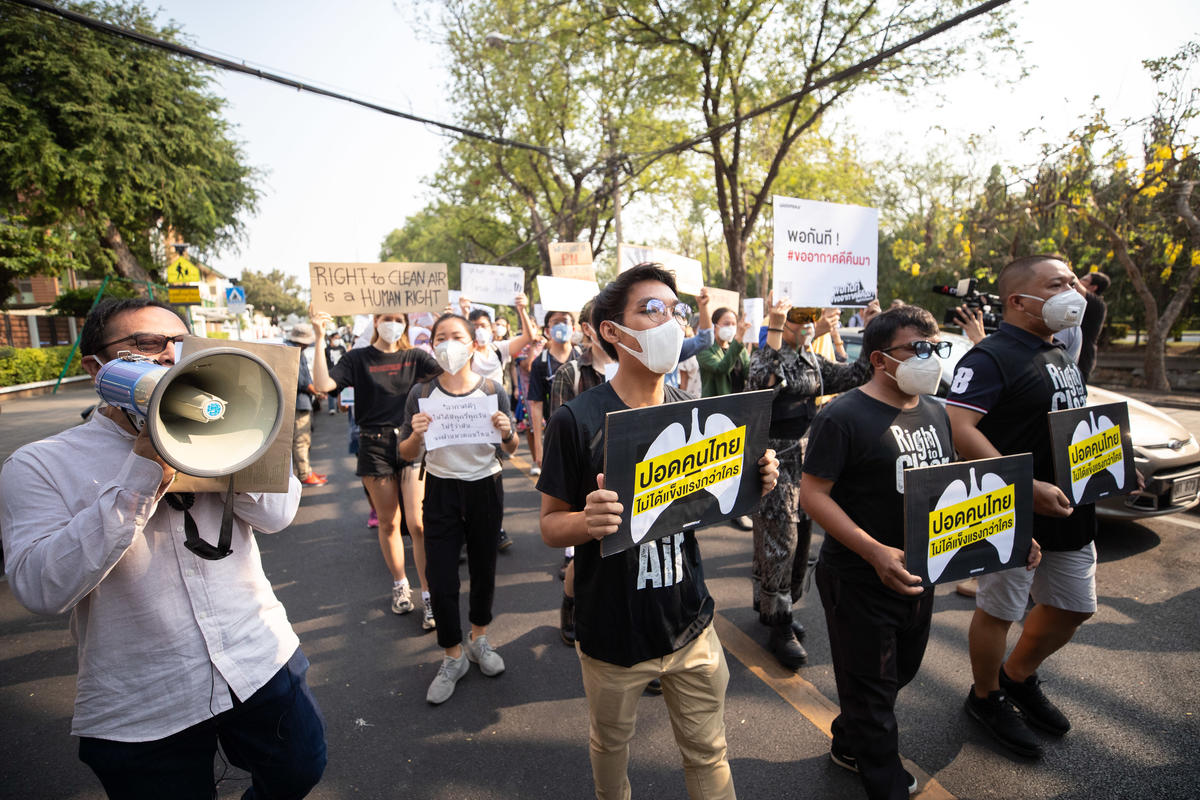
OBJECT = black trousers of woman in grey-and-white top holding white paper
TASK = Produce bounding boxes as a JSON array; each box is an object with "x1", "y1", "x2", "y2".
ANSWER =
[{"x1": 424, "y1": 473, "x2": 504, "y2": 648}]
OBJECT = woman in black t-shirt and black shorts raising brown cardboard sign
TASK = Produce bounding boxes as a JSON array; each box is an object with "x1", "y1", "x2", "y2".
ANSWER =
[{"x1": 312, "y1": 312, "x2": 442, "y2": 631}]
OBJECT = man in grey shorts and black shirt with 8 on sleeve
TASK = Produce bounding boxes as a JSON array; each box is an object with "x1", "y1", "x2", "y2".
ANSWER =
[{"x1": 947, "y1": 255, "x2": 1096, "y2": 758}]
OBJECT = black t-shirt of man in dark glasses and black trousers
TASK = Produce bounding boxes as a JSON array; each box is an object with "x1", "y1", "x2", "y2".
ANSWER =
[{"x1": 804, "y1": 389, "x2": 954, "y2": 583}]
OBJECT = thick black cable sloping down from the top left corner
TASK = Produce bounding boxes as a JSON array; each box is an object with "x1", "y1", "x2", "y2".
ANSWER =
[{"x1": 7, "y1": 0, "x2": 554, "y2": 158}]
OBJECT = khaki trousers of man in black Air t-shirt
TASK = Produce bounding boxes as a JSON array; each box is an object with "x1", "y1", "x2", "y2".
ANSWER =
[{"x1": 576, "y1": 625, "x2": 737, "y2": 800}]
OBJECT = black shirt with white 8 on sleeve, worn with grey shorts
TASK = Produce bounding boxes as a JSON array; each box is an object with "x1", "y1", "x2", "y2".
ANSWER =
[{"x1": 946, "y1": 323, "x2": 1096, "y2": 551}]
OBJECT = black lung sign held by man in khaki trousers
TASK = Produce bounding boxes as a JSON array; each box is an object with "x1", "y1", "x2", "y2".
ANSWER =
[{"x1": 601, "y1": 390, "x2": 773, "y2": 555}]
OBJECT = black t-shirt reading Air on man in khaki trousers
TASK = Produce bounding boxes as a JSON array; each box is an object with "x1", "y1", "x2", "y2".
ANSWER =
[{"x1": 538, "y1": 384, "x2": 713, "y2": 667}]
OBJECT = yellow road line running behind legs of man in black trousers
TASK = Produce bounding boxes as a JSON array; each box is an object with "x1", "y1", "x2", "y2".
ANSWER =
[{"x1": 713, "y1": 614, "x2": 955, "y2": 800}]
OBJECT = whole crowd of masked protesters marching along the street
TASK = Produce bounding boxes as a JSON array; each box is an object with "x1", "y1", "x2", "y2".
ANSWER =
[{"x1": 0, "y1": 255, "x2": 1104, "y2": 800}]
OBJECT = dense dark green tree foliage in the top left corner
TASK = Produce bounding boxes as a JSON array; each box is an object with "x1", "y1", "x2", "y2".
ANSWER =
[{"x1": 0, "y1": 2, "x2": 256, "y2": 300}]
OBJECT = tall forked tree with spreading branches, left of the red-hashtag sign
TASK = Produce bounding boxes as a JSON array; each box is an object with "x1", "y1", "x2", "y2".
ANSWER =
[{"x1": 604, "y1": 0, "x2": 1010, "y2": 293}]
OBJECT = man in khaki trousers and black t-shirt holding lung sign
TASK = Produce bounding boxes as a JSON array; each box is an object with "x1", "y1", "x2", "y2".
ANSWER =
[{"x1": 538, "y1": 264, "x2": 779, "y2": 799}]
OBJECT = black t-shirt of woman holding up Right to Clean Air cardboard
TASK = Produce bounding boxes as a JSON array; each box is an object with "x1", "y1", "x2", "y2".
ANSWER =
[{"x1": 329, "y1": 347, "x2": 442, "y2": 428}]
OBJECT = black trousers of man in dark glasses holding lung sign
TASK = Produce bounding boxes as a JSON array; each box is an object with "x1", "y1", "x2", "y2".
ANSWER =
[{"x1": 816, "y1": 561, "x2": 934, "y2": 800}]
